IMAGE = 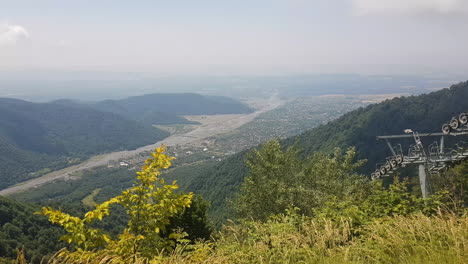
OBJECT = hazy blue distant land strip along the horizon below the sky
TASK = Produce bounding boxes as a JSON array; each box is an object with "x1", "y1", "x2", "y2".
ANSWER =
[{"x1": 0, "y1": 71, "x2": 458, "y2": 101}]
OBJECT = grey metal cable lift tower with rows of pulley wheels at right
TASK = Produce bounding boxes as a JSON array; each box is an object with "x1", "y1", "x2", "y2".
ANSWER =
[{"x1": 371, "y1": 113, "x2": 468, "y2": 198}]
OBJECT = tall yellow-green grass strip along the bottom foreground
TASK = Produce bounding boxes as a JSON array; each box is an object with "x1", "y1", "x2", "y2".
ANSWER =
[{"x1": 22, "y1": 213, "x2": 468, "y2": 264}]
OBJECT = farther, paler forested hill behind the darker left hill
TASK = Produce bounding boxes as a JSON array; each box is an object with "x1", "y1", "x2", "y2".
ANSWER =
[{"x1": 91, "y1": 93, "x2": 252, "y2": 125}]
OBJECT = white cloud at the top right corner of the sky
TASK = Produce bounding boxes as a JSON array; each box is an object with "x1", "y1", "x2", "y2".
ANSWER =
[{"x1": 352, "y1": 0, "x2": 468, "y2": 15}]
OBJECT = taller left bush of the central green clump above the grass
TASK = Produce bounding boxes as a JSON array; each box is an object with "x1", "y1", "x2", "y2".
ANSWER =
[{"x1": 235, "y1": 140, "x2": 303, "y2": 219}]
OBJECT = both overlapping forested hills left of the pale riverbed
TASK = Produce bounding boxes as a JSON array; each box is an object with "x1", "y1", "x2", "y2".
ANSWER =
[{"x1": 0, "y1": 94, "x2": 253, "y2": 189}]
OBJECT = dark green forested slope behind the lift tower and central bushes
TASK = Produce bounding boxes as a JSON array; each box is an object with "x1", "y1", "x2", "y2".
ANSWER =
[{"x1": 175, "y1": 82, "x2": 468, "y2": 221}]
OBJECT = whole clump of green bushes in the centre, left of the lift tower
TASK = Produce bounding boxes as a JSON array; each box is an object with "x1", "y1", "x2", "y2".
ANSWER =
[{"x1": 235, "y1": 140, "x2": 366, "y2": 220}]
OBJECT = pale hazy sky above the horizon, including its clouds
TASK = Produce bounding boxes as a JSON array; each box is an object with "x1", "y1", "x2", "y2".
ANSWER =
[{"x1": 0, "y1": 0, "x2": 468, "y2": 74}]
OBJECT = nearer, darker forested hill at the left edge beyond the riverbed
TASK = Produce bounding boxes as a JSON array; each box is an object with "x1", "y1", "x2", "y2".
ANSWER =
[{"x1": 0, "y1": 99, "x2": 168, "y2": 188}]
